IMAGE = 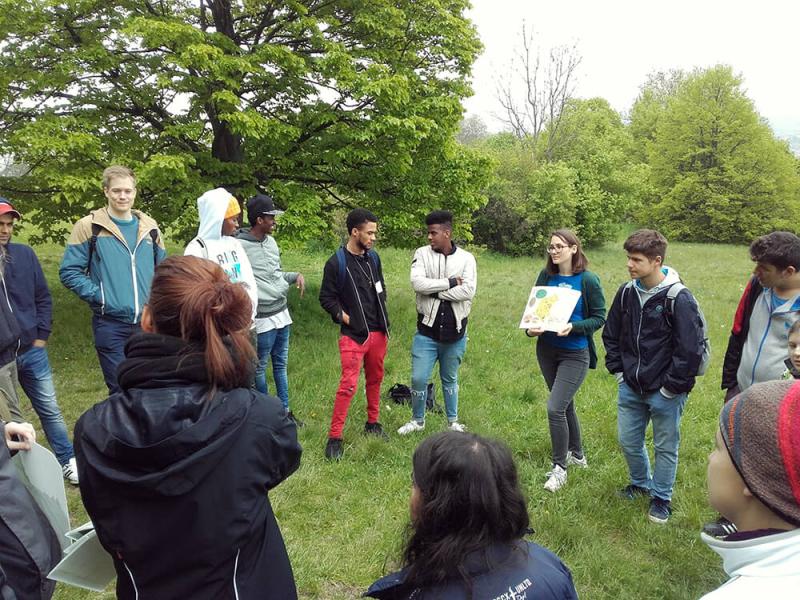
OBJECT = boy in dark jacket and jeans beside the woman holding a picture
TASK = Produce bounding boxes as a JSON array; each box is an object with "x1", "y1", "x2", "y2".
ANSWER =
[{"x1": 603, "y1": 229, "x2": 703, "y2": 523}]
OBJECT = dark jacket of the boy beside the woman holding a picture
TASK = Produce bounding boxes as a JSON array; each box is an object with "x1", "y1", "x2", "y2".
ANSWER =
[{"x1": 603, "y1": 276, "x2": 703, "y2": 395}]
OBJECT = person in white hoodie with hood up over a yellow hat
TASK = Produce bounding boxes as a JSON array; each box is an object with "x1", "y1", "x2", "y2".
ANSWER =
[{"x1": 183, "y1": 188, "x2": 258, "y2": 319}]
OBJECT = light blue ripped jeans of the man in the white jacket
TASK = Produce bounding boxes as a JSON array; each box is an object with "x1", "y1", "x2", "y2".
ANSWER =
[{"x1": 411, "y1": 332, "x2": 467, "y2": 423}]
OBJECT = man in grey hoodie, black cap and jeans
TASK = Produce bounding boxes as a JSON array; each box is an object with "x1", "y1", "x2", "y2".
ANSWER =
[{"x1": 236, "y1": 194, "x2": 306, "y2": 427}]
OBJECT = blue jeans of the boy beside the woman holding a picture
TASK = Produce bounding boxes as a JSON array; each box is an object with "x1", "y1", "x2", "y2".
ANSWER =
[{"x1": 617, "y1": 382, "x2": 687, "y2": 500}]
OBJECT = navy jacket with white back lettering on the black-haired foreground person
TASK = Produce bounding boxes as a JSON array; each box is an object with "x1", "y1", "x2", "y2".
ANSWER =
[{"x1": 364, "y1": 540, "x2": 578, "y2": 600}]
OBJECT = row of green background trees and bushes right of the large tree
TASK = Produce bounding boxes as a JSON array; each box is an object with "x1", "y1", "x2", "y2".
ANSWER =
[{"x1": 466, "y1": 66, "x2": 800, "y2": 255}]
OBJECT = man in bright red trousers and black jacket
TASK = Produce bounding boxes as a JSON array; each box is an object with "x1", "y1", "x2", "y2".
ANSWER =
[{"x1": 319, "y1": 208, "x2": 389, "y2": 460}]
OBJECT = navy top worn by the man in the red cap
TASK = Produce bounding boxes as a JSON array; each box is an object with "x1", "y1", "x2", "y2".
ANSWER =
[{"x1": 5, "y1": 243, "x2": 53, "y2": 354}]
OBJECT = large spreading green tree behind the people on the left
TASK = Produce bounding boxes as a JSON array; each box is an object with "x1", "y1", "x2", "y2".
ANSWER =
[{"x1": 0, "y1": 0, "x2": 487, "y2": 240}]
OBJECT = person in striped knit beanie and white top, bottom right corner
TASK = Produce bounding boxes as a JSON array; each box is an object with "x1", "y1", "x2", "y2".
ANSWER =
[{"x1": 701, "y1": 380, "x2": 800, "y2": 600}]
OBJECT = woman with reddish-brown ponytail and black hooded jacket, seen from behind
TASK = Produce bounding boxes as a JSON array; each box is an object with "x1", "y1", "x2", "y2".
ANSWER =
[{"x1": 75, "y1": 256, "x2": 302, "y2": 600}]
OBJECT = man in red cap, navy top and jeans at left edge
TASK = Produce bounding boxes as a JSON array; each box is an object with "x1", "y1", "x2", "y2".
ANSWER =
[{"x1": 0, "y1": 198, "x2": 78, "y2": 485}]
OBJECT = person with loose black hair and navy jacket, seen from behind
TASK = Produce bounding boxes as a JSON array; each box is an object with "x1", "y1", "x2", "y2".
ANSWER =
[{"x1": 365, "y1": 430, "x2": 578, "y2": 600}]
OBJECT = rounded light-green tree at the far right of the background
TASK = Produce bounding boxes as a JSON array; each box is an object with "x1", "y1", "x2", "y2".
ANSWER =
[{"x1": 645, "y1": 66, "x2": 800, "y2": 242}]
